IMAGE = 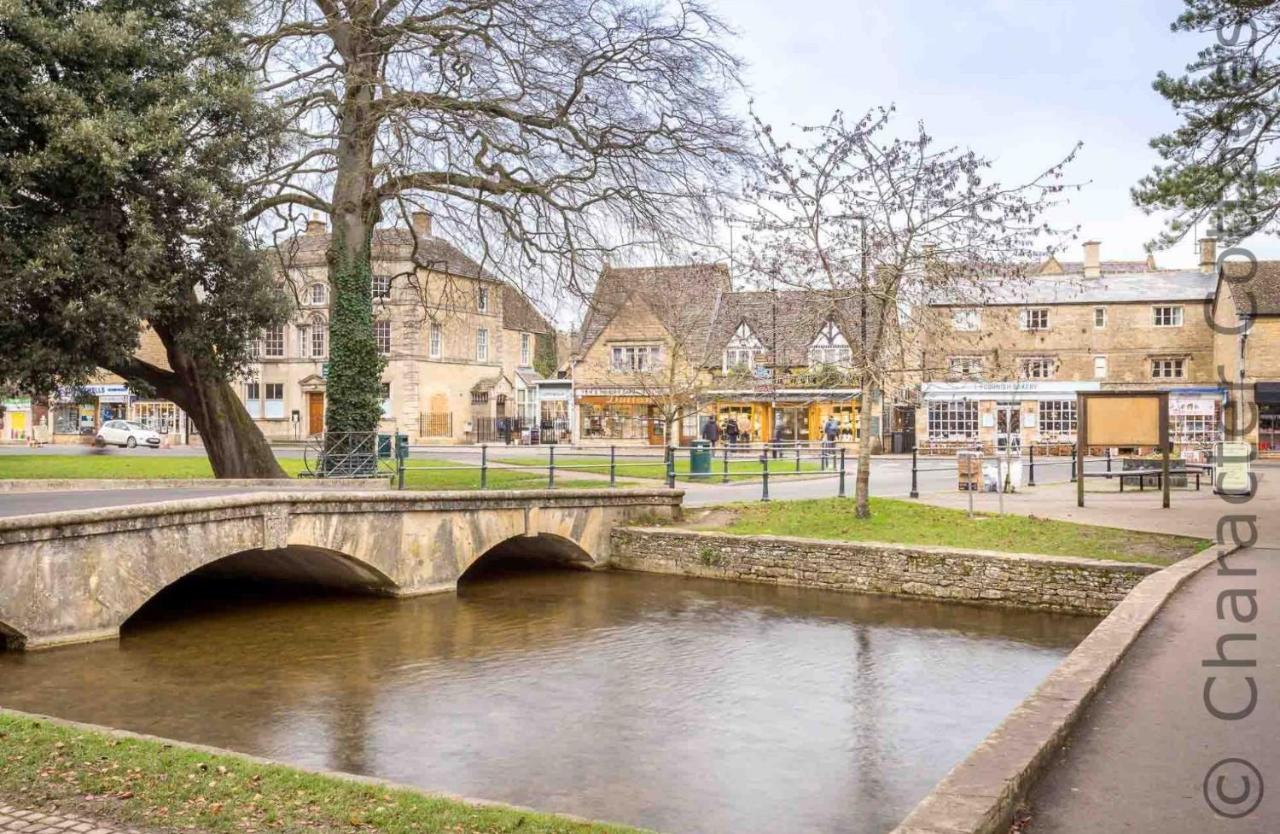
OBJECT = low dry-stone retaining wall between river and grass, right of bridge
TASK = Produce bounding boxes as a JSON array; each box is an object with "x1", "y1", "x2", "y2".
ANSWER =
[{"x1": 609, "y1": 527, "x2": 1158, "y2": 615}]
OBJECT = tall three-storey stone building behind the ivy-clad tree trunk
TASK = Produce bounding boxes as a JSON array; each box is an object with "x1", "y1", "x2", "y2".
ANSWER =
[{"x1": 239, "y1": 212, "x2": 554, "y2": 443}]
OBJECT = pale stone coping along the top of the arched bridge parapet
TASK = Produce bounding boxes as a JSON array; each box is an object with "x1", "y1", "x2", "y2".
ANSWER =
[{"x1": 0, "y1": 489, "x2": 685, "y2": 533}]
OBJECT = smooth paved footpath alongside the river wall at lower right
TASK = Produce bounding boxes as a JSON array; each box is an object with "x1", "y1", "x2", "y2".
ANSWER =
[{"x1": 1028, "y1": 542, "x2": 1280, "y2": 834}]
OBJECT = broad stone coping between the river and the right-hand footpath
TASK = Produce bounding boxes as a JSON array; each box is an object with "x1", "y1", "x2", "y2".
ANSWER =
[{"x1": 891, "y1": 545, "x2": 1235, "y2": 834}]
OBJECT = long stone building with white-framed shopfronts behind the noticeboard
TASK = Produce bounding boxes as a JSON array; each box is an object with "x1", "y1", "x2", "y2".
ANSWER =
[{"x1": 916, "y1": 239, "x2": 1228, "y2": 452}]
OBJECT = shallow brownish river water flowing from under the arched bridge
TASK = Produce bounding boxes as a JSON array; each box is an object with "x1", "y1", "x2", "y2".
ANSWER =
[{"x1": 0, "y1": 568, "x2": 1096, "y2": 834}]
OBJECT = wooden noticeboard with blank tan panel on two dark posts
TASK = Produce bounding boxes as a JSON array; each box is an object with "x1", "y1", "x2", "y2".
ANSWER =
[{"x1": 1075, "y1": 391, "x2": 1171, "y2": 509}]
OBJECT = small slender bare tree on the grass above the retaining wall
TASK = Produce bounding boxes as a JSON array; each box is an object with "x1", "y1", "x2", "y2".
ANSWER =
[{"x1": 746, "y1": 109, "x2": 1079, "y2": 518}]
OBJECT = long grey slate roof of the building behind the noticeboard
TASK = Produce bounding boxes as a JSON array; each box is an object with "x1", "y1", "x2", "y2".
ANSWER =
[{"x1": 929, "y1": 270, "x2": 1217, "y2": 307}]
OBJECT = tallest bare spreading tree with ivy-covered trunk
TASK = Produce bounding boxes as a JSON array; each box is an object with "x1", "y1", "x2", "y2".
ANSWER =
[{"x1": 248, "y1": 0, "x2": 742, "y2": 429}]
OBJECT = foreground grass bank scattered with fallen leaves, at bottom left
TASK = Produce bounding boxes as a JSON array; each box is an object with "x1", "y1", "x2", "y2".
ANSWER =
[{"x1": 0, "y1": 712, "x2": 636, "y2": 834}]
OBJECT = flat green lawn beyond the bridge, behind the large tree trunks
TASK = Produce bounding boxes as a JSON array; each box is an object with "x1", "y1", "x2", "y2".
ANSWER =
[{"x1": 0, "y1": 453, "x2": 619, "y2": 490}]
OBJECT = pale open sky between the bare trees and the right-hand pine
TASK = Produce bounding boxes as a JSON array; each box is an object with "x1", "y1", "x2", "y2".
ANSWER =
[{"x1": 727, "y1": 0, "x2": 1280, "y2": 266}]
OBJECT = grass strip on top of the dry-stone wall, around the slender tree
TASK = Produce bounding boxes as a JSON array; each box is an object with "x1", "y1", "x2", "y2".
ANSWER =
[{"x1": 698, "y1": 498, "x2": 1212, "y2": 564}]
